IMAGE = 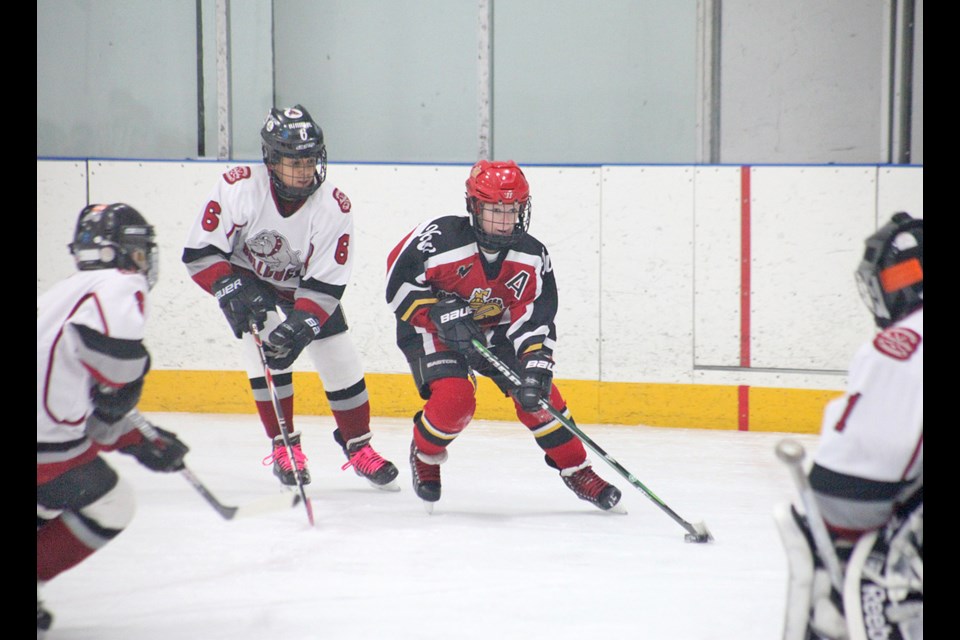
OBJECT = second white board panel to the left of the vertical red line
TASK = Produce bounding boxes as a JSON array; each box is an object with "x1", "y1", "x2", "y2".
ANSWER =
[{"x1": 600, "y1": 167, "x2": 693, "y2": 383}]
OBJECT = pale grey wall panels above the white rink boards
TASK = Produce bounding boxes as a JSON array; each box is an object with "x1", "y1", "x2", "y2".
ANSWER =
[{"x1": 37, "y1": 0, "x2": 923, "y2": 164}]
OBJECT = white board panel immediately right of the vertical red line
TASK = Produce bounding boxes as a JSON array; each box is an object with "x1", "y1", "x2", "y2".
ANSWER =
[{"x1": 750, "y1": 167, "x2": 876, "y2": 371}]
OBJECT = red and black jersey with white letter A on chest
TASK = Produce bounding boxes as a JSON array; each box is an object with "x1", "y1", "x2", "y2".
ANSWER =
[{"x1": 387, "y1": 215, "x2": 557, "y2": 361}]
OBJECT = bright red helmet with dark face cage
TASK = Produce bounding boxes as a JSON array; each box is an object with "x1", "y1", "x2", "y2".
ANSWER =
[{"x1": 466, "y1": 160, "x2": 532, "y2": 250}]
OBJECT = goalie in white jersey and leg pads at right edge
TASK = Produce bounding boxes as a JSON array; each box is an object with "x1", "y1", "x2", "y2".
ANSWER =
[{"x1": 775, "y1": 212, "x2": 923, "y2": 640}]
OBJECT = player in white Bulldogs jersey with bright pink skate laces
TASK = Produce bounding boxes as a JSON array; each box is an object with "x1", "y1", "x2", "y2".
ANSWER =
[{"x1": 183, "y1": 105, "x2": 398, "y2": 490}]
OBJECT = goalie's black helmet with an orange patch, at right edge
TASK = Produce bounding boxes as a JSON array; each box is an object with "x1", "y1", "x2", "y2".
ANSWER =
[{"x1": 856, "y1": 211, "x2": 923, "y2": 328}]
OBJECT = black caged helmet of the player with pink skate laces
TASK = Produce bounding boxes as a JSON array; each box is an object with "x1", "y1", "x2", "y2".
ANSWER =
[{"x1": 260, "y1": 104, "x2": 327, "y2": 200}]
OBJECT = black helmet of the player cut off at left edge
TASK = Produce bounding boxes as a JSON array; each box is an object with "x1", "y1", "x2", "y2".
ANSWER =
[{"x1": 67, "y1": 202, "x2": 159, "y2": 288}]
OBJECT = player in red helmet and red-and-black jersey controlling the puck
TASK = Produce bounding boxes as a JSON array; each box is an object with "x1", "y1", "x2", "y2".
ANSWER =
[{"x1": 386, "y1": 160, "x2": 620, "y2": 510}]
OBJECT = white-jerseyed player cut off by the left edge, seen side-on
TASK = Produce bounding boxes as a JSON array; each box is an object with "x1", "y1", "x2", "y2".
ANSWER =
[{"x1": 37, "y1": 203, "x2": 188, "y2": 636}]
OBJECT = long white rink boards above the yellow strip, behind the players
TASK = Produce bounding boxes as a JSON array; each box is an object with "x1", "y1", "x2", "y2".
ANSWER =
[{"x1": 37, "y1": 160, "x2": 923, "y2": 389}]
